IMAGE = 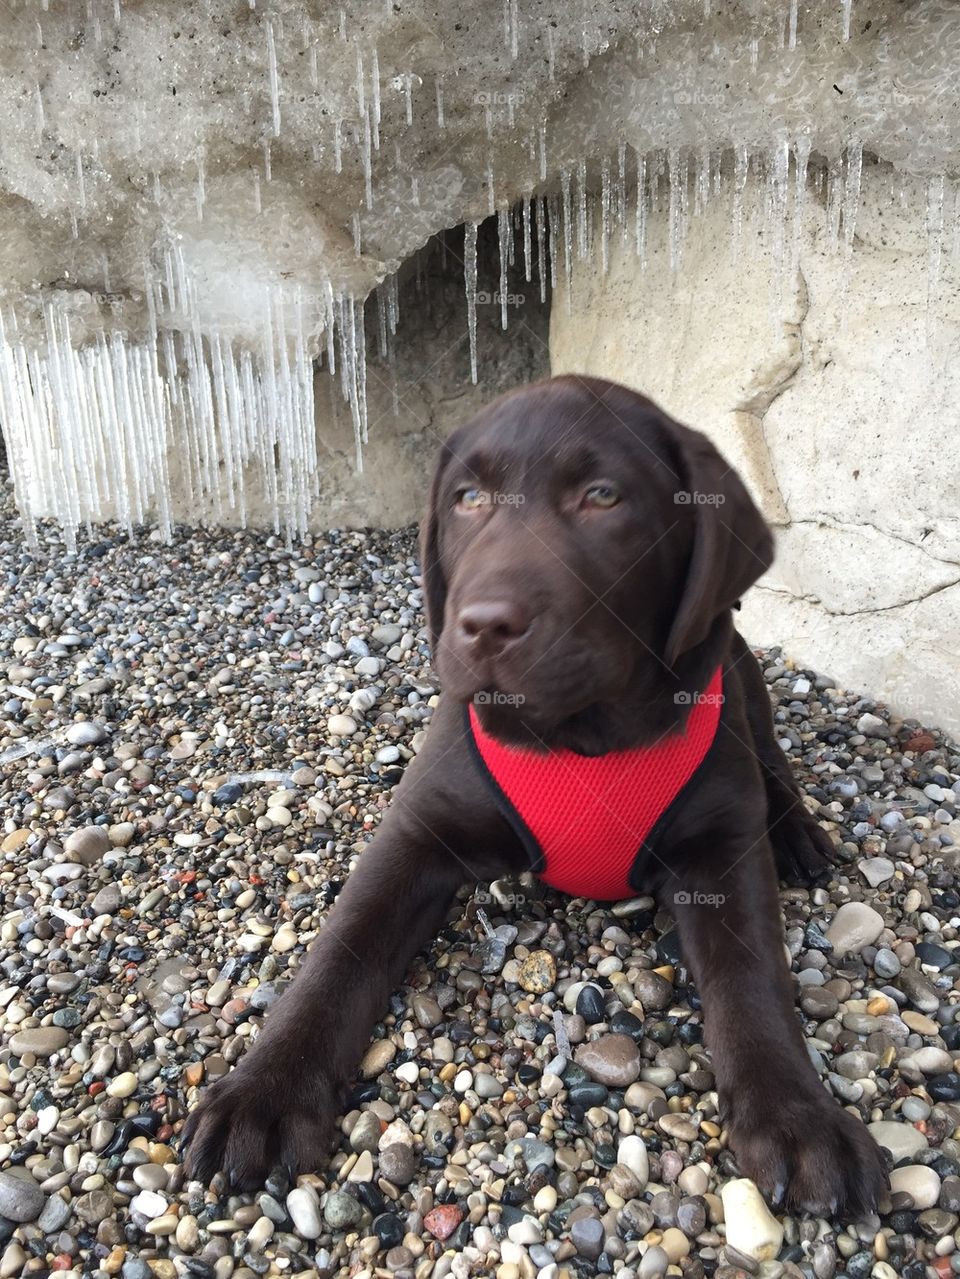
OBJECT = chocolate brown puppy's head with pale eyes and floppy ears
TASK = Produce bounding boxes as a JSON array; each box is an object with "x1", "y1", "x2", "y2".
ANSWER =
[{"x1": 421, "y1": 377, "x2": 773, "y2": 743}]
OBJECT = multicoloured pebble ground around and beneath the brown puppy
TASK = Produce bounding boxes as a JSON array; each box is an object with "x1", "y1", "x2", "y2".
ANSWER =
[{"x1": 0, "y1": 491, "x2": 960, "y2": 1279}]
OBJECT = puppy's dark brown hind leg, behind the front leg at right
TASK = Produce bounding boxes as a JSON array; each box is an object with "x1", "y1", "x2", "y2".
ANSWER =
[{"x1": 731, "y1": 634, "x2": 836, "y2": 884}]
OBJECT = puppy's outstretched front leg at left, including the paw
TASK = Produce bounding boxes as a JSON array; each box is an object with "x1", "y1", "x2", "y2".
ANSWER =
[{"x1": 184, "y1": 828, "x2": 470, "y2": 1189}]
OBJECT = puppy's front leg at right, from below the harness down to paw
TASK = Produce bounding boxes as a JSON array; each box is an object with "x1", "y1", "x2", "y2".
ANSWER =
[{"x1": 662, "y1": 838, "x2": 886, "y2": 1218}]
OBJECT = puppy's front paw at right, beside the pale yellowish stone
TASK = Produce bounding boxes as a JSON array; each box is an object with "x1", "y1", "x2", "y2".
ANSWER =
[{"x1": 730, "y1": 1092, "x2": 890, "y2": 1220}]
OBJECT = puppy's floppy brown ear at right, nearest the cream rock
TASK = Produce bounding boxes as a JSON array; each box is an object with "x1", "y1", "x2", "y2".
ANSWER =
[{"x1": 665, "y1": 423, "x2": 773, "y2": 666}]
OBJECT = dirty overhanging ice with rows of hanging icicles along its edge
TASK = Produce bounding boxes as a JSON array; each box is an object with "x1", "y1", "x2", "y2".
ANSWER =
[{"x1": 0, "y1": 0, "x2": 960, "y2": 538}]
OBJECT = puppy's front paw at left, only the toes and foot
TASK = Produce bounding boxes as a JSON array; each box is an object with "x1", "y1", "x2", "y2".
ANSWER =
[{"x1": 182, "y1": 1063, "x2": 336, "y2": 1191}]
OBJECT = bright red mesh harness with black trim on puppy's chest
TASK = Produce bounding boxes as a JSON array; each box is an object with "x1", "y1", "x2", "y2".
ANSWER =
[{"x1": 468, "y1": 666, "x2": 724, "y2": 902}]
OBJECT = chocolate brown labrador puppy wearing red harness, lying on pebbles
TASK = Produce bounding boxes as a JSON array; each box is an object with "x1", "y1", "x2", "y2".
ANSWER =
[{"x1": 185, "y1": 377, "x2": 886, "y2": 1215}]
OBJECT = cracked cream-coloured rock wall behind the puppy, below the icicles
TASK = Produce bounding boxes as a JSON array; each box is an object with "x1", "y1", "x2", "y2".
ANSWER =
[{"x1": 551, "y1": 164, "x2": 960, "y2": 730}]
